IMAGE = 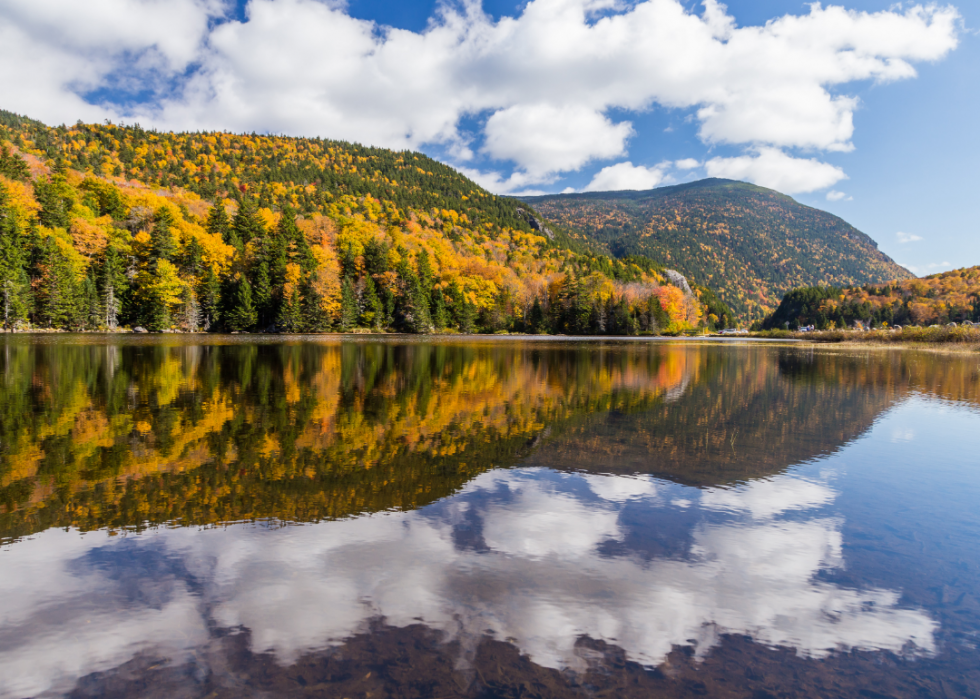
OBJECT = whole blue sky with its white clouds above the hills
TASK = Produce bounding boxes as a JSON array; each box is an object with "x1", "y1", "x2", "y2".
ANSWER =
[{"x1": 0, "y1": 0, "x2": 980, "y2": 274}]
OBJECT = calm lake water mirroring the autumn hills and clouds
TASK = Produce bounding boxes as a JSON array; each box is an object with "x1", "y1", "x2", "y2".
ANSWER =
[{"x1": 0, "y1": 336, "x2": 980, "y2": 699}]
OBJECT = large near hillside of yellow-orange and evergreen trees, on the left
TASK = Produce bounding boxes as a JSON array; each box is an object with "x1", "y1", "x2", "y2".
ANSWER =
[{"x1": 0, "y1": 111, "x2": 731, "y2": 334}]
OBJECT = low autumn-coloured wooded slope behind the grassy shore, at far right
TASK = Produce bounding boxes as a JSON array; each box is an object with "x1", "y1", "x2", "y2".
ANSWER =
[{"x1": 762, "y1": 267, "x2": 980, "y2": 330}]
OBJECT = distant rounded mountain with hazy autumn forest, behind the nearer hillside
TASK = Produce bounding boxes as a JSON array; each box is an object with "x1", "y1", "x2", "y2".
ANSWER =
[{"x1": 524, "y1": 179, "x2": 912, "y2": 318}]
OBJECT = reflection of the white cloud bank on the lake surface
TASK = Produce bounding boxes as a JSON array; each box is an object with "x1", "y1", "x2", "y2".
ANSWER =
[{"x1": 0, "y1": 469, "x2": 936, "y2": 696}]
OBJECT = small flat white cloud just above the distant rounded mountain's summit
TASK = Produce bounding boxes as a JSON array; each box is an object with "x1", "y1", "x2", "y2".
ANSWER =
[{"x1": 704, "y1": 148, "x2": 847, "y2": 194}]
